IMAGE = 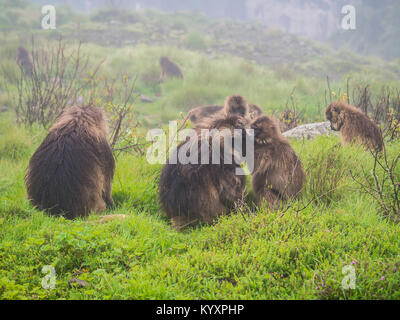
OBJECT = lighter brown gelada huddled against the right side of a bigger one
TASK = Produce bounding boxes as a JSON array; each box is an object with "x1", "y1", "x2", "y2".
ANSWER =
[{"x1": 251, "y1": 116, "x2": 304, "y2": 209}]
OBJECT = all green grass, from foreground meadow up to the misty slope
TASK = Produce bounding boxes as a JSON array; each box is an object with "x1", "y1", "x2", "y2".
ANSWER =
[{"x1": 0, "y1": 0, "x2": 400, "y2": 299}]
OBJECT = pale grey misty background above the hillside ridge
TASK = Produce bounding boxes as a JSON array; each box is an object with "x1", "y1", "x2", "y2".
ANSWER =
[{"x1": 25, "y1": 0, "x2": 400, "y2": 60}]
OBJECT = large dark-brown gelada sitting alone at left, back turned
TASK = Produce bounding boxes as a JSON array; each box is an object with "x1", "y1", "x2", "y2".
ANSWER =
[{"x1": 25, "y1": 107, "x2": 115, "y2": 219}]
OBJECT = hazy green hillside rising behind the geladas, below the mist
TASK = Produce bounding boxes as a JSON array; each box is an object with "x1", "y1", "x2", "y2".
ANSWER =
[{"x1": 0, "y1": 0, "x2": 400, "y2": 127}]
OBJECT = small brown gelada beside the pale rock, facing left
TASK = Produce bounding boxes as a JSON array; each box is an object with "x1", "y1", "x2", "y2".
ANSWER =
[{"x1": 325, "y1": 101, "x2": 383, "y2": 151}]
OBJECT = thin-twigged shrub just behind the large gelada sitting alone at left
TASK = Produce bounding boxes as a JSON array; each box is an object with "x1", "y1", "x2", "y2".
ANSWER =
[{"x1": 10, "y1": 38, "x2": 101, "y2": 128}]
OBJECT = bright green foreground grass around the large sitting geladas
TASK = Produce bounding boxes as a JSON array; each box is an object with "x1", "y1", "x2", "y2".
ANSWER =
[{"x1": 0, "y1": 114, "x2": 400, "y2": 299}]
